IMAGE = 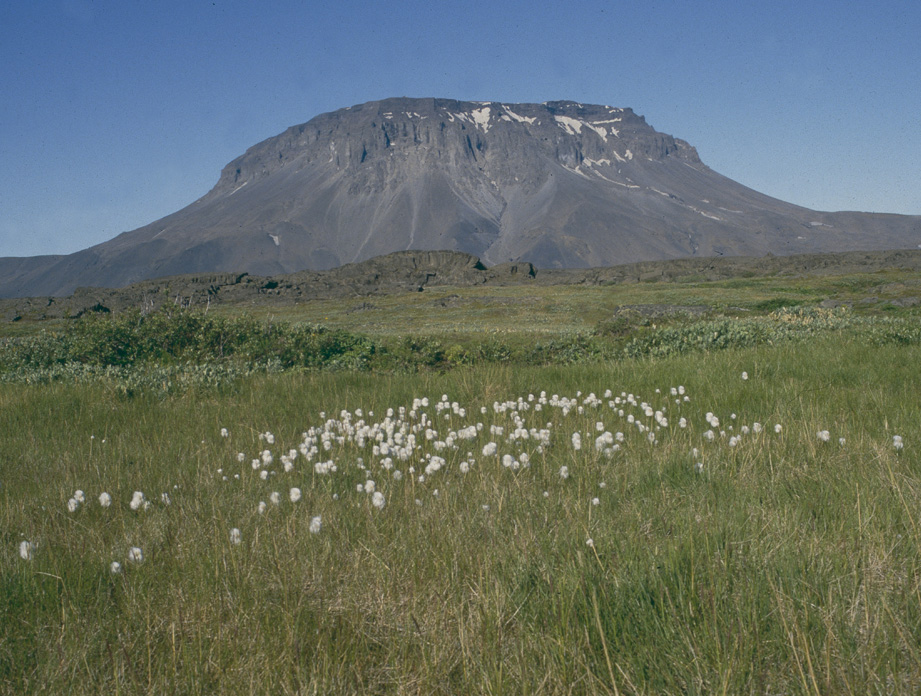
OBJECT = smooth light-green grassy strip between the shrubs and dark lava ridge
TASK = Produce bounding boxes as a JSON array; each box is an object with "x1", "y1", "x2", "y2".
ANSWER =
[{"x1": 205, "y1": 270, "x2": 921, "y2": 336}]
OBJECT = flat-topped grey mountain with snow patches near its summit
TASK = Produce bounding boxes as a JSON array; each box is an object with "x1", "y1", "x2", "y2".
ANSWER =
[{"x1": 0, "y1": 98, "x2": 921, "y2": 297}]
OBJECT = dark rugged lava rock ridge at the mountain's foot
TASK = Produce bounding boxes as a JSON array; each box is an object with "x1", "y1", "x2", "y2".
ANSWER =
[{"x1": 0, "y1": 250, "x2": 921, "y2": 322}]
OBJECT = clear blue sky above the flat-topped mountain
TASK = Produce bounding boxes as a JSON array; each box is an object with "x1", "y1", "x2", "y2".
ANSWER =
[{"x1": 0, "y1": 0, "x2": 921, "y2": 256}]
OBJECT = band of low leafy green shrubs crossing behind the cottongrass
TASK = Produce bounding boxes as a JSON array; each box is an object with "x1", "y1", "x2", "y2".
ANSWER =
[{"x1": 0, "y1": 307, "x2": 921, "y2": 395}]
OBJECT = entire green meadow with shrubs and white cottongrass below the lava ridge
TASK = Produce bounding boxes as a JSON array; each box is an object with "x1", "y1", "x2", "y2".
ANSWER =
[{"x1": 0, "y1": 274, "x2": 921, "y2": 694}]
